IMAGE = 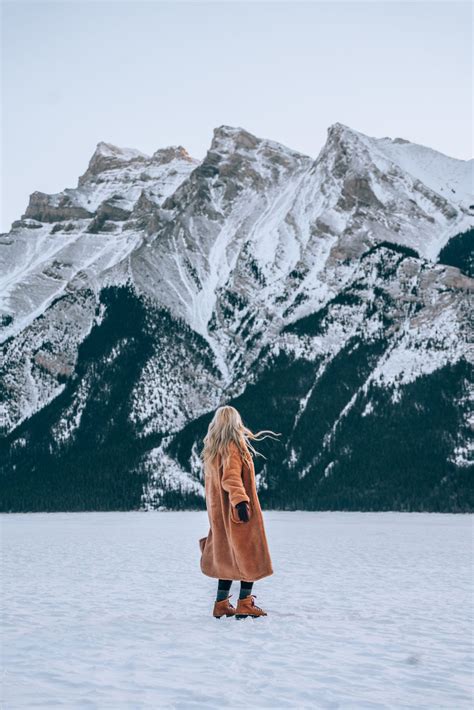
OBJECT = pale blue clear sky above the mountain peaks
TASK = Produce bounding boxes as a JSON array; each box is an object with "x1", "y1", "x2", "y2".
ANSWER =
[{"x1": 0, "y1": 0, "x2": 473, "y2": 231}]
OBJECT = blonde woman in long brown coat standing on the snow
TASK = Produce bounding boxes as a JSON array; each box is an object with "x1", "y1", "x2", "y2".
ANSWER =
[{"x1": 199, "y1": 406, "x2": 274, "y2": 619}]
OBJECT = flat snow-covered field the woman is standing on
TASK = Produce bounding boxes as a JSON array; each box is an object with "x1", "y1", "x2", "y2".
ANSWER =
[{"x1": 1, "y1": 512, "x2": 473, "y2": 710}]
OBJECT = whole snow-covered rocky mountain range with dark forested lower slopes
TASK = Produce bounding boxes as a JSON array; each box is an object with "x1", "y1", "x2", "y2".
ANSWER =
[{"x1": 0, "y1": 123, "x2": 474, "y2": 510}]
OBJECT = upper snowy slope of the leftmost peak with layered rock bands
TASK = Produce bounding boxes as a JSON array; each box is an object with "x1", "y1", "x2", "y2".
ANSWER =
[{"x1": 0, "y1": 143, "x2": 196, "y2": 340}]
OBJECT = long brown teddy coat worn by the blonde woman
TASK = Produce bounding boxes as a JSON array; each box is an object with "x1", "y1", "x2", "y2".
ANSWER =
[{"x1": 199, "y1": 442, "x2": 273, "y2": 582}]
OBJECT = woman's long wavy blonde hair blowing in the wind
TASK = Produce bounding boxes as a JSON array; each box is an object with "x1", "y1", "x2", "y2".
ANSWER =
[{"x1": 201, "y1": 405, "x2": 280, "y2": 469}]
